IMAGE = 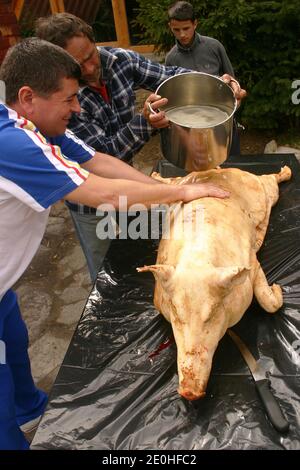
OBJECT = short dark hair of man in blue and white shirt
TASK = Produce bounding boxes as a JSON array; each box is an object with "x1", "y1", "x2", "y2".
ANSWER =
[{"x1": 0, "y1": 38, "x2": 81, "y2": 104}]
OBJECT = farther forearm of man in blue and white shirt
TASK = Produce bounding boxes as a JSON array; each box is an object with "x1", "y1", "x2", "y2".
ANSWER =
[{"x1": 82, "y1": 152, "x2": 161, "y2": 184}]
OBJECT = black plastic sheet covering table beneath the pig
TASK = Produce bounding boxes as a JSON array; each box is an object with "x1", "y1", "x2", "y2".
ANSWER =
[{"x1": 32, "y1": 154, "x2": 300, "y2": 450}]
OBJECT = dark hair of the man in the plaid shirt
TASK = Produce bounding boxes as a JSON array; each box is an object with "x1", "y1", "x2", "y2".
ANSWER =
[{"x1": 35, "y1": 13, "x2": 95, "y2": 48}]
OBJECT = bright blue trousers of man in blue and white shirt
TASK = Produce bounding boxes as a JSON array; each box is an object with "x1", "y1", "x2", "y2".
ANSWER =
[{"x1": 0, "y1": 290, "x2": 47, "y2": 450}]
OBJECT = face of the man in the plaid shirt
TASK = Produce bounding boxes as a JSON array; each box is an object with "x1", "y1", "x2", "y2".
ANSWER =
[{"x1": 65, "y1": 36, "x2": 100, "y2": 85}]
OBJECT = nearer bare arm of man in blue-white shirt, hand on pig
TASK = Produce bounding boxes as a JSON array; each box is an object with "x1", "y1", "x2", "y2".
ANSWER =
[{"x1": 65, "y1": 174, "x2": 229, "y2": 210}]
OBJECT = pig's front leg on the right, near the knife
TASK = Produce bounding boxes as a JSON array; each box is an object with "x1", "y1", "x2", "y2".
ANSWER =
[{"x1": 253, "y1": 264, "x2": 283, "y2": 313}]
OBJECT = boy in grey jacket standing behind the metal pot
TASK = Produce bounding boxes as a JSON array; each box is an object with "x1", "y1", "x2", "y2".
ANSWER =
[{"x1": 165, "y1": 1, "x2": 241, "y2": 155}]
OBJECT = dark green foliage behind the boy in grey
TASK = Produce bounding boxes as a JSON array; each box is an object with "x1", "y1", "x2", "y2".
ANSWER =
[{"x1": 136, "y1": 0, "x2": 300, "y2": 130}]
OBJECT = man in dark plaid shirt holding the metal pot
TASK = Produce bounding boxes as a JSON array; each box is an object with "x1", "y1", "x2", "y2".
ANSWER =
[{"x1": 36, "y1": 13, "x2": 244, "y2": 280}]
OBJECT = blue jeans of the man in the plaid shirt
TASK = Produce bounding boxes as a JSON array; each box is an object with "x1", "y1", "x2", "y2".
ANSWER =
[{"x1": 70, "y1": 209, "x2": 111, "y2": 282}]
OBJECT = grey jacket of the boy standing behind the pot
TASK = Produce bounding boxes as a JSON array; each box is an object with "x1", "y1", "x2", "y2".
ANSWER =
[{"x1": 166, "y1": 33, "x2": 234, "y2": 76}]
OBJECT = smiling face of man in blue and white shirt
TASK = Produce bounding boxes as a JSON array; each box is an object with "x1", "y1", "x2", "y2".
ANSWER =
[{"x1": 28, "y1": 78, "x2": 80, "y2": 137}]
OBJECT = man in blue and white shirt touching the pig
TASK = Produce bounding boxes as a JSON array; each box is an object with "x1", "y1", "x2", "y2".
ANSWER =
[{"x1": 0, "y1": 38, "x2": 228, "y2": 450}]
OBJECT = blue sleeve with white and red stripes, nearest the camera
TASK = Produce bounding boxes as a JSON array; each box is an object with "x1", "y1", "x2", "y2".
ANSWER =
[{"x1": 0, "y1": 129, "x2": 89, "y2": 211}]
